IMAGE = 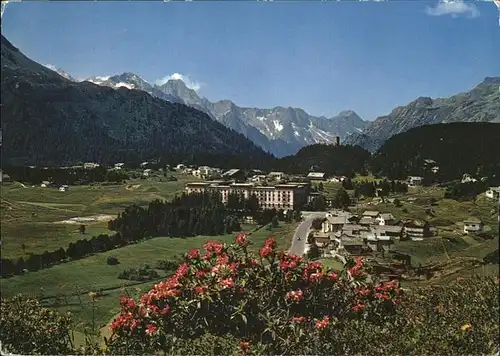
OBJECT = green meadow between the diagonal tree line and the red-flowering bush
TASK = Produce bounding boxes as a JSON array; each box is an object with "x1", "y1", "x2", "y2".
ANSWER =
[{"x1": 2, "y1": 223, "x2": 296, "y2": 331}]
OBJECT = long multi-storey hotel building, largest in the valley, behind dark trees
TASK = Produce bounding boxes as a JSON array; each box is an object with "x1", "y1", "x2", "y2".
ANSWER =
[{"x1": 186, "y1": 181, "x2": 307, "y2": 209}]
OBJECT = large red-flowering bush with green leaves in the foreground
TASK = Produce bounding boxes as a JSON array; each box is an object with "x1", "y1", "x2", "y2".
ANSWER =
[{"x1": 108, "y1": 234, "x2": 401, "y2": 354}]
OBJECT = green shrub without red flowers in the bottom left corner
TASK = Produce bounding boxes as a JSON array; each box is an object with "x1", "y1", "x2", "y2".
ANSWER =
[{"x1": 0, "y1": 295, "x2": 72, "y2": 355}]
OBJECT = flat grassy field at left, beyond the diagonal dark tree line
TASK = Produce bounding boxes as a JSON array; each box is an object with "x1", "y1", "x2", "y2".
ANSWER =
[{"x1": 0, "y1": 174, "x2": 202, "y2": 258}]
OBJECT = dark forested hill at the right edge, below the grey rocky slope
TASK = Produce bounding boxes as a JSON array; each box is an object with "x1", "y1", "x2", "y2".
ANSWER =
[{"x1": 371, "y1": 122, "x2": 500, "y2": 181}]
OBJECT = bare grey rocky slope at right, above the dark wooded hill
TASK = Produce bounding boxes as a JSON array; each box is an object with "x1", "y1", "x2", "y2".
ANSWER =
[{"x1": 344, "y1": 77, "x2": 500, "y2": 152}]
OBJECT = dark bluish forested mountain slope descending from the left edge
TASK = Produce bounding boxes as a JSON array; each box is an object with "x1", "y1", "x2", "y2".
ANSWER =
[{"x1": 1, "y1": 36, "x2": 271, "y2": 169}]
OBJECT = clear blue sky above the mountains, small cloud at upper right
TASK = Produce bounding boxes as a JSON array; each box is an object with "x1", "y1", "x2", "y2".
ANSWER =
[{"x1": 2, "y1": 1, "x2": 500, "y2": 120}]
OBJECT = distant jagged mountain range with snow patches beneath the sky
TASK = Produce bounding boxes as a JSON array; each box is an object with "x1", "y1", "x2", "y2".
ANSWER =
[{"x1": 62, "y1": 73, "x2": 367, "y2": 157}]
